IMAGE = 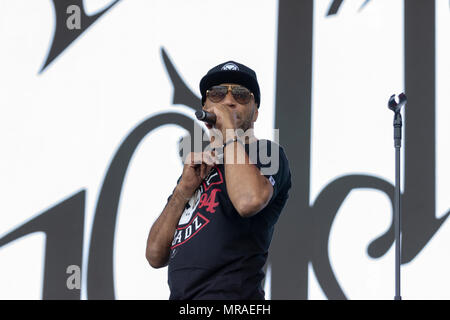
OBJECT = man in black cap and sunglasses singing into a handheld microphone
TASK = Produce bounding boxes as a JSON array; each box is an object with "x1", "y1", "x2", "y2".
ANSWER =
[{"x1": 146, "y1": 61, "x2": 291, "y2": 299}]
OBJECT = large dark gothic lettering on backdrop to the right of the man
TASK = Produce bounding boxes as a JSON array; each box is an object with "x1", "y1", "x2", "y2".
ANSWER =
[{"x1": 271, "y1": 0, "x2": 450, "y2": 299}]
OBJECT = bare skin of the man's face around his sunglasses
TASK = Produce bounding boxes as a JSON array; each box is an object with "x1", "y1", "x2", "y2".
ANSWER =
[{"x1": 203, "y1": 83, "x2": 258, "y2": 131}]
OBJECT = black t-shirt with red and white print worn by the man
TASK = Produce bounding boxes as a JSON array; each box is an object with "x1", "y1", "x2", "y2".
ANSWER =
[{"x1": 168, "y1": 140, "x2": 291, "y2": 300}]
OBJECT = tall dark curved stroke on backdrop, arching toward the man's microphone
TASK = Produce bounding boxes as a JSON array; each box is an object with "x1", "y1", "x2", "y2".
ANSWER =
[{"x1": 87, "y1": 112, "x2": 203, "y2": 299}]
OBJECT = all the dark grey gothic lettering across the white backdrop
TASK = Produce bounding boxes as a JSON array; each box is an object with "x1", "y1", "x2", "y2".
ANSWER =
[{"x1": 0, "y1": 0, "x2": 450, "y2": 299}]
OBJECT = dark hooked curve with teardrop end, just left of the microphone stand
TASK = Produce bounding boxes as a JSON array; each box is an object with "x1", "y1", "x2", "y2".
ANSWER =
[{"x1": 311, "y1": 175, "x2": 394, "y2": 299}]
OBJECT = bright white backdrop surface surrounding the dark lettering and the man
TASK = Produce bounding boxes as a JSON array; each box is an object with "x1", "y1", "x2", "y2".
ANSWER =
[{"x1": 0, "y1": 0, "x2": 450, "y2": 299}]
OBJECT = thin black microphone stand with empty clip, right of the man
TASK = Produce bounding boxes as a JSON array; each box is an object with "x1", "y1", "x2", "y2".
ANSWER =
[{"x1": 388, "y1": 93, "x2": 406, "y2": 300}]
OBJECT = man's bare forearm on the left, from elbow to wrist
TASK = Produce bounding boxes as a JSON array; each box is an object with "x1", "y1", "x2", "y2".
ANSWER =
[{"x1": 145, "y1": 184, "x2": 188, "y2": 268}]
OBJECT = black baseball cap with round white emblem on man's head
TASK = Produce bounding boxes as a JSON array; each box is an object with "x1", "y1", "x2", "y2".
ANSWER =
[{"x1": 200, "y1": 61, "x2": 261, "y2": 108}]
